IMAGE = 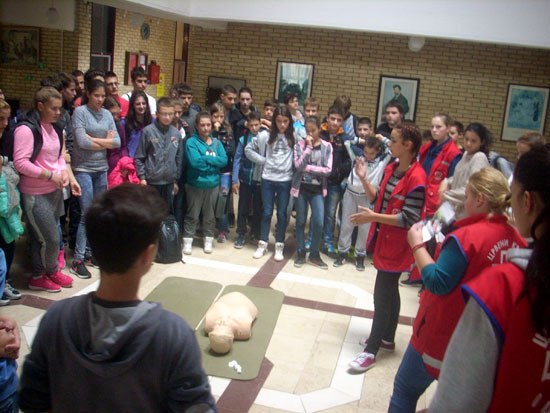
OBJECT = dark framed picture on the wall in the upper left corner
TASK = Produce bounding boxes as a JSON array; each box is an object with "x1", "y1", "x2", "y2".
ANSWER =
[{"x1": 0, "y1": 27, "x2": 40, "y2": 65}]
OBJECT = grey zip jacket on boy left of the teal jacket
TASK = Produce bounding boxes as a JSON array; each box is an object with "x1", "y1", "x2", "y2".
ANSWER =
[{"x1": 134, "y1": 120, "x2": 183, "y2": 185}]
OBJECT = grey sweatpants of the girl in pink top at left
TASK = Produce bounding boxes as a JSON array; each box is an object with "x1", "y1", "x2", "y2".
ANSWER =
[{"x1": 21, "y1": 189, "x2": 63, "y2": 277}]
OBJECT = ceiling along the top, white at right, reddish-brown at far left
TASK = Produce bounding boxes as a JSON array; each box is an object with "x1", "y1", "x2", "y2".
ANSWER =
[{"x1": 0, "y1": 0, "x2": 550, "y2": 49}]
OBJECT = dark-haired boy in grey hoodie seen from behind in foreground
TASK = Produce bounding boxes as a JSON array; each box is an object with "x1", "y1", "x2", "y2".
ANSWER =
[{"x1": 19, "y1": 183, "x2": 217, "y2": 412}]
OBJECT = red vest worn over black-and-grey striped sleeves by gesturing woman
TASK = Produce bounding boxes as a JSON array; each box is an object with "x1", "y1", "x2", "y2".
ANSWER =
[{"x1": 367, "y1": 161, "x2": 426, "y2": 272}]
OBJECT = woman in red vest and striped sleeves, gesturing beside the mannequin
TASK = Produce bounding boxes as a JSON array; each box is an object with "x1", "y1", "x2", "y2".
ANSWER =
[{"x1": 349, "y1": 122, "x2": 426, "y2": 371}]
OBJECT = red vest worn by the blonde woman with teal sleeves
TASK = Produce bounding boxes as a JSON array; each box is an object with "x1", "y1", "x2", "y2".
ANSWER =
[{"x1": 411, "y1": 214, "x2": 525, "y2": 379}]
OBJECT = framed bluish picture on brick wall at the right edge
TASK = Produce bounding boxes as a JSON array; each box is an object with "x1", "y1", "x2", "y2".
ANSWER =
[{"x1": 502, "y1": 84, "x2": 550, "y2": 142}]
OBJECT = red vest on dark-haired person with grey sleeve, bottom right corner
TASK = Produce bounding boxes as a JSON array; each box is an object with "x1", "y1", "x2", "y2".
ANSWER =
[{"x1": 462, "y1": 263, "x2": 550, "y2": 412}]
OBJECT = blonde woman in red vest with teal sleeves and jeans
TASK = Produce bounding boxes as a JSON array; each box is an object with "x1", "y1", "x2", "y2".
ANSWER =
[{"x1": 389, "y1": 168, "x2": 525, "y2": 412}]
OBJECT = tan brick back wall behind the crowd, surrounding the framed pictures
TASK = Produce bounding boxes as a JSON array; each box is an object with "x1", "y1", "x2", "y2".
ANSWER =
[{"x1": 187, "y1": 23, "x2": 550, "y2": 158}]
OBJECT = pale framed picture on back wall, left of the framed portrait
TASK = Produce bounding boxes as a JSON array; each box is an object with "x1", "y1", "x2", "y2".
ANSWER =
[{"x1": 275, "y1": 62, "x2": 314, "y2": 105}]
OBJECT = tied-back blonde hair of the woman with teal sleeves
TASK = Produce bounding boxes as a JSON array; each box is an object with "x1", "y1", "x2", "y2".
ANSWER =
[{"x1": 468, "y1": 168, "x2": 510, "y2": 214}]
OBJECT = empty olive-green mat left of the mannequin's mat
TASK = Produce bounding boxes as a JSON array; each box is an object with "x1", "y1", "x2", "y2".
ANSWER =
[{"x1": 145, "y1": 277, "x2": 222, "y2": 329}]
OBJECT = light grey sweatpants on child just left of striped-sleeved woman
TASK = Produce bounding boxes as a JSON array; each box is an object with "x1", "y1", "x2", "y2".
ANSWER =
[{"x1": 338, "y1": 189, "x2": 372, "y2": 257}]
